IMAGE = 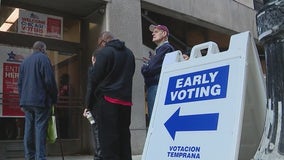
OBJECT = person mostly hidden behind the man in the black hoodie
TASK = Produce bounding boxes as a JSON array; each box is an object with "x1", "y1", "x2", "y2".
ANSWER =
[{"x1": 83, "y1": 48, "x2": 102, "y2": 160}]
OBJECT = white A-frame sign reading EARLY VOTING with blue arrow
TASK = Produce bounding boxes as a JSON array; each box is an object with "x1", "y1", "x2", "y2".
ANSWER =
[{"x1": 142, "y1": 32, "x2": 266, "y2": 160}]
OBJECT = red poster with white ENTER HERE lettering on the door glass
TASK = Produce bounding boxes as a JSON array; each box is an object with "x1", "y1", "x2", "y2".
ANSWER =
[{"x1": 0, "y1": 44, "x2": 32, "y2": 117}]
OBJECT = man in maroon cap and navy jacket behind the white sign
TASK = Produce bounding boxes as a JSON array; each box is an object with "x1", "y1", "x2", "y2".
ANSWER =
[{"x1": 141, "y1": 24, "x2": 175, "y2": 119}]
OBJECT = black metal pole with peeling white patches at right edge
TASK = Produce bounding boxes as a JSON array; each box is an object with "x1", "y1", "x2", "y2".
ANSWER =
[{"x1": 254, "y1": 0, "x2": 284, "y2": 160}]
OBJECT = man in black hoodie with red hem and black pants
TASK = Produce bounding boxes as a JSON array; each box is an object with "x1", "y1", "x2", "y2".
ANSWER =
[{"x1": 86, "y1": 31, "x2": 135, "y2": 160}]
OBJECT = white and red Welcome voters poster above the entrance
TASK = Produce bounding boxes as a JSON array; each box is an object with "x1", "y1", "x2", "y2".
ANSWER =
[{"x1": 18, "y1": 9, "x2": 63, "y2": 39}]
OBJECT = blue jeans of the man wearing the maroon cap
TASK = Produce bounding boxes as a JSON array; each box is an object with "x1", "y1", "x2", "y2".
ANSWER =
[{"x1": 146, "y1": 85, "x2": 158, "y2": 120}]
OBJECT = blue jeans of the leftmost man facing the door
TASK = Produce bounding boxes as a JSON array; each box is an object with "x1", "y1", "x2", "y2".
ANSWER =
[{"x1": 23, "y1": 106, "x2": 50, "y2": 160}]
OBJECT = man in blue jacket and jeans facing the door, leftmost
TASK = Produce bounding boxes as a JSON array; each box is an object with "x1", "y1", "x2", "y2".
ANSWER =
[{"x1": 18, "y1": 41, "x2": 58, "y2": 160}]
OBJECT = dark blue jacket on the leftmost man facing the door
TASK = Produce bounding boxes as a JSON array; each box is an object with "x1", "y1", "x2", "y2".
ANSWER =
[{"x1": 18, "y1": 52, "x2": 58, "y2": 107}]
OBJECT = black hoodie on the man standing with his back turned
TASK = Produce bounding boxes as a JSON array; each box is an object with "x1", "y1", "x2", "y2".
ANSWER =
[{"x1": 86, "y1": 39, "x2": 135, "y2": 108}]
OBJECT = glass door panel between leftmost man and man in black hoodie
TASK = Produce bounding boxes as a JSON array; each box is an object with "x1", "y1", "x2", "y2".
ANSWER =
[{"x1": 48, "y1": 51, "x2": 83, "y2": 154}]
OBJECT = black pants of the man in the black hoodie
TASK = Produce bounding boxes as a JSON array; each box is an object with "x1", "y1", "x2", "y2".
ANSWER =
[{"x1": 96, "y1": 98, "x2": 132, "y2": 160}]
